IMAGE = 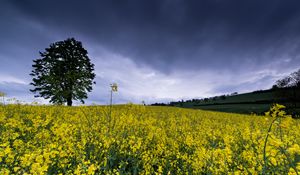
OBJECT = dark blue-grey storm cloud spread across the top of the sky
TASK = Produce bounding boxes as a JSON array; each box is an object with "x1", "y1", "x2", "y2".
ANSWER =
[{"x1": 9, "y1": 0, "x2": 300, "y2": 72}]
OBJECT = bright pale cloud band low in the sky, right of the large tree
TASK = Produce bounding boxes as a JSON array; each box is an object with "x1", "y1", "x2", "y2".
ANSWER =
[{"x1": 84, "y1": 47, "x2": 298, "y2": 104}]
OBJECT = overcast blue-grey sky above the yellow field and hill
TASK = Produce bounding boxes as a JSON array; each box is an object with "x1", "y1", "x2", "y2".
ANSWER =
[{"x1": 0, "y1": 0, "x2": 300, "y2": 104}]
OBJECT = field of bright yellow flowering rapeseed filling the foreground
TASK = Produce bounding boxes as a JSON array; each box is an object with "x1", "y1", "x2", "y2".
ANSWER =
[{"x1": 0, "y1": 105, "x2": 300, "y2": 175}]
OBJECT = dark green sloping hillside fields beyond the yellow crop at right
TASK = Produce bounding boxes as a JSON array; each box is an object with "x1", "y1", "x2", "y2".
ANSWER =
[{"x1": 170, "y1": 89, "x2": 300, "y2": 114}]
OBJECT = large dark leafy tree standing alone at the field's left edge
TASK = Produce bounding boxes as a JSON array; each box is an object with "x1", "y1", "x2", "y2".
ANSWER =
[{"x1": 30, "y1": 38, "x2": 95, "y2": 106}]
